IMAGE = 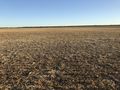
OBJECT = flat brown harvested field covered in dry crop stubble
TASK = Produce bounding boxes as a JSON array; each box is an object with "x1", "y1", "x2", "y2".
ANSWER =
[{"x1": 0, "y1": 27, "x2": 120, "y2": 90}]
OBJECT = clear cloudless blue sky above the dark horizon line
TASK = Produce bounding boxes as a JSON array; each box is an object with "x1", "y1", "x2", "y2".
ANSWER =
[{"x1": 0, "y1": 0, "x2": 120, "y2": 27}]
